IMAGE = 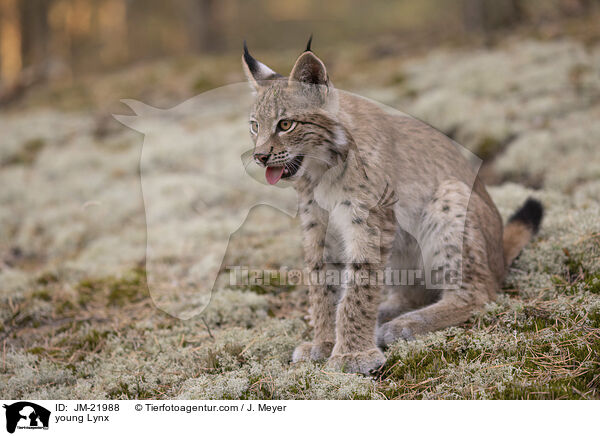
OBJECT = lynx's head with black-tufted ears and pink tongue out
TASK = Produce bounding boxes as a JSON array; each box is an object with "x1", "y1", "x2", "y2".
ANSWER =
[{"x1": 242, "y1": 37, "x2": 345, "y2": 185}]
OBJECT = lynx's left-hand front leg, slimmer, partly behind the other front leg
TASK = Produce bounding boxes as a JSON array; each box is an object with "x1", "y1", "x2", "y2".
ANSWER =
[{"x1": 292, "y1": 197, "x2": 339, "y2": 362}]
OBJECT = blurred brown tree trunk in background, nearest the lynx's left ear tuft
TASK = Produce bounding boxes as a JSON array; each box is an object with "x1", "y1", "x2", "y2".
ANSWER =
[{"x1": 188, "y1": 0, "x2": 223, "y2": 53}]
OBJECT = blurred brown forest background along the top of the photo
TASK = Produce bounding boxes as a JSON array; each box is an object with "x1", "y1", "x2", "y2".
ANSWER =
[{"x1": 0, "y1": 0, "x2": 599, "y2": 105}]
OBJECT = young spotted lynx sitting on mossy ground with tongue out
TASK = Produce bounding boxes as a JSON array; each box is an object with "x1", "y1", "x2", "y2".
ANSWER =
[{"x1": 242, "y1": 41, "x2": 542, "y2": 374}]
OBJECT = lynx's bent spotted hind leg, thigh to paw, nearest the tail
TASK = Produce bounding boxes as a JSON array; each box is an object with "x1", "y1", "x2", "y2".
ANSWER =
[{"x1": 377, "y1": 182, "x2": 499, "y2": 347}]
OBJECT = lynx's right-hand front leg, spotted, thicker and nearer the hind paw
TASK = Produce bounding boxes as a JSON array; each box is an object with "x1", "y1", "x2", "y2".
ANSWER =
[{"x1": 329, "y1": 209, "x2": 394, "y2": 374}]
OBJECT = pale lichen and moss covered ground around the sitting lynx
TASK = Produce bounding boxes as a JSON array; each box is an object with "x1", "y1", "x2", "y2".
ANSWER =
[{"x1": 0, "y1": 32, "x2": 600, "y2": 399}]
